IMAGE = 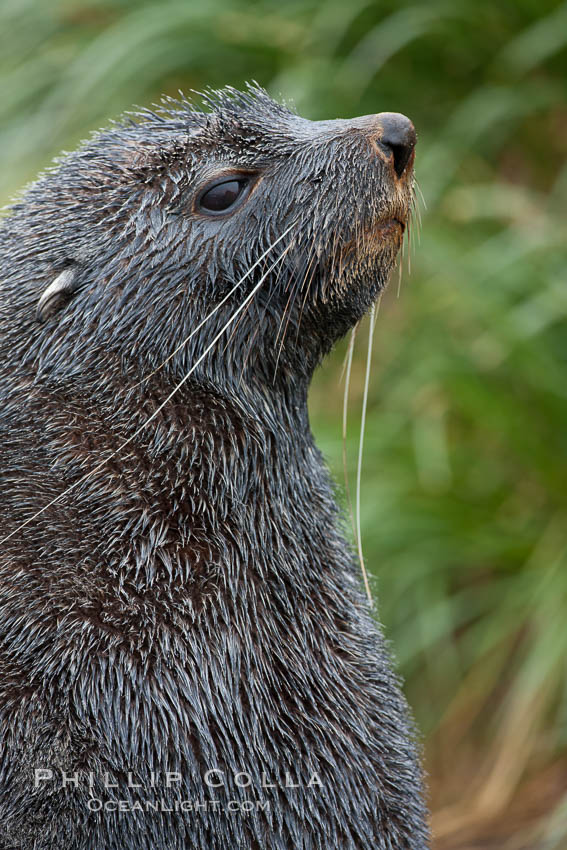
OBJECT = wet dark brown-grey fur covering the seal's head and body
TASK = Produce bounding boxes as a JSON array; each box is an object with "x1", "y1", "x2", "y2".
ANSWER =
[{"x1": 0, "y1": 89, "x2": 427, "y2": 850}]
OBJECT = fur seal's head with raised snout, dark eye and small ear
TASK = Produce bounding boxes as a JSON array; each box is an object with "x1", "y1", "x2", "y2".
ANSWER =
[{"x1": 11, "y1": 86, "x2": 416, "y2": 380}]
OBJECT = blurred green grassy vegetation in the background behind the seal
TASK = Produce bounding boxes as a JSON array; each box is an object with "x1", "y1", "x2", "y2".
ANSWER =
[{"x1": 0, "y1": 0, "x2": 567, "y2": 850}]
